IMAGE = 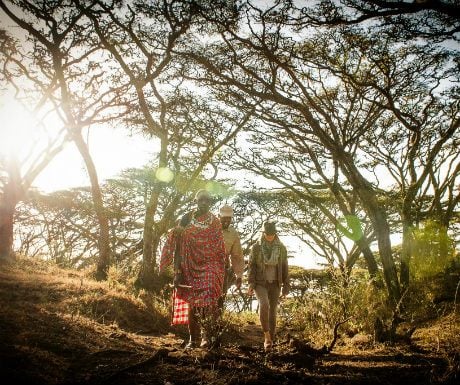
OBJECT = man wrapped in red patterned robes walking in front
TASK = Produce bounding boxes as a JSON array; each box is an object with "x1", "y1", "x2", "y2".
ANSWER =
[{"x1": 160, "y1": 190, "x2": 226, "y2": 348}]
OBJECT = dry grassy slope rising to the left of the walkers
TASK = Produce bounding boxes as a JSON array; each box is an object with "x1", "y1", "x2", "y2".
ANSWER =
[{"x1": 0, "y1": 259, "x2": 172, "y2": 384}]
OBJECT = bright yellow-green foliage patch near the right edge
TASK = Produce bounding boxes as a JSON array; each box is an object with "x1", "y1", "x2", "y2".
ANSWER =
[{"x1": 410, "y1": 220, "x2": 455, "y2": 280}]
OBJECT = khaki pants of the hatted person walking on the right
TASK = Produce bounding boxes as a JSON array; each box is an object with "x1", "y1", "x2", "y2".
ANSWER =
[{"x1": 254, "y1": 281, "x2": 281, "y2": 341}]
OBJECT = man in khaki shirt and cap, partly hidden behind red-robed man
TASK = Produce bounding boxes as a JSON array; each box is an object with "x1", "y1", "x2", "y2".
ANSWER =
[{"x1": 219, "y1": 205, "x2": 244, "y2": 312}]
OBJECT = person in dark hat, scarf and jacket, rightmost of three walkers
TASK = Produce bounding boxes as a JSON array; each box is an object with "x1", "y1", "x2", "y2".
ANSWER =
[{"x1": 248, "y1": 221, "x2": 289, "y2": 352}]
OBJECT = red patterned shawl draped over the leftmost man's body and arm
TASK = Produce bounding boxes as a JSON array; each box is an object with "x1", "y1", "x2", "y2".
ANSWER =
[{"x1": 160, "y1": 213, "x2": 226, "y2": 324}]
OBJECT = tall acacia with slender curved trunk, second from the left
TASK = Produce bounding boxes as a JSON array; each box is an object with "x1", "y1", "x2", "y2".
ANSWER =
[{"x1": 0, "y1": 1, "x2": 129, "y2": 279}]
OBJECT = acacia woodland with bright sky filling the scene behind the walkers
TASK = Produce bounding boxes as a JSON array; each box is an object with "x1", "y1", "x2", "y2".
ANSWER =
[{"x1": 0, "y1": 0, "x2": 460, "y2": 380}]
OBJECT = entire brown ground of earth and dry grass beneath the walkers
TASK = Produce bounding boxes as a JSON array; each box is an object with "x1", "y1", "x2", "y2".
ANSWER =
[{"x1": 0, "y1": 260, "x2": 459, "y2": 385}]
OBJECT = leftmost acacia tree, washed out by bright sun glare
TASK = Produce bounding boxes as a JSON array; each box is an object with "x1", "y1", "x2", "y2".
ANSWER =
[{"x1": 0, "y1": 26, "x2": 67, "y2": 259}]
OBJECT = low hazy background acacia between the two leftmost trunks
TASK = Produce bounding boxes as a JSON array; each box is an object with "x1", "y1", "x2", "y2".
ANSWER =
[{"x1": 15, "y1": 188, "x2": 98, "y2": 268}]
